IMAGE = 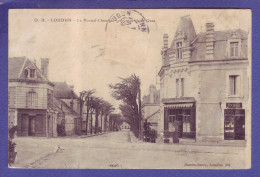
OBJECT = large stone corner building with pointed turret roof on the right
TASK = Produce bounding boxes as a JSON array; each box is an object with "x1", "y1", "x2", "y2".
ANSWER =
[{"x1": 159, "y1": 16, "x2": 251, "y2": 142}]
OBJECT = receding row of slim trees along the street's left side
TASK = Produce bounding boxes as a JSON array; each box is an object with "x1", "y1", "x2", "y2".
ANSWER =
[{"x1": 79, "y1": 90, "x2": 121, "y2": 134}]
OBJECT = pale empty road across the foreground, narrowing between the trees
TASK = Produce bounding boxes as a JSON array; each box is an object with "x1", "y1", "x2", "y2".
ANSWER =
[{"x1": 13, "y1": 130, "x2": 249, "y2": 169}]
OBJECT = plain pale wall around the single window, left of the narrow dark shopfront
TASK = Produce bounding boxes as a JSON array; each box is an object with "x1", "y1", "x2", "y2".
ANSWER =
[{"x1": 193, "y1": 61, "x2": 249, "y2": 141}]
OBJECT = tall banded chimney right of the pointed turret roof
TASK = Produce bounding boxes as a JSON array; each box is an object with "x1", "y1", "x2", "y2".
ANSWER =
[{"x1": 205, "y1": 23, "x2": 214, "y2": 59}]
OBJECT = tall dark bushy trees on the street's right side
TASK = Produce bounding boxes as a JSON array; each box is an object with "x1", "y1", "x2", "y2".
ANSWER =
[{"x1": 109, "y1": 74, "x2": 142, "y2": 137}]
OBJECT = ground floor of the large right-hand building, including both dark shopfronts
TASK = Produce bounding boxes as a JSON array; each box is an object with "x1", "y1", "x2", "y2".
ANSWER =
[{"x1": 163, "y1": 98, "x2": 248, "y2": 142}]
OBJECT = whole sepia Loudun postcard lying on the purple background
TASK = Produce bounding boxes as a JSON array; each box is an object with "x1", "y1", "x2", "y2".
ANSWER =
[{"x1": 8, "y1": 9, "x2": 252, "y2": 169}]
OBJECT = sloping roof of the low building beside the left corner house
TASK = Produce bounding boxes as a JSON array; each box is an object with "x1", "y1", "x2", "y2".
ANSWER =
[{"x1": 53, "y1": 82, "x2": 78, "y2": 99}]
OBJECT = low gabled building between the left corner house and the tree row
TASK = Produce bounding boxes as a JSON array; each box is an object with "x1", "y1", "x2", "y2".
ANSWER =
[{"x1": 54, "y1": 82, "x2": 79, "y2": 135}]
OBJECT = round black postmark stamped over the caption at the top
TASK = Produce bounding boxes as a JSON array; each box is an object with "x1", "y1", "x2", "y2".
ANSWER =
[{"x1": 105, "y1": 10, "x2": 149, "y2": 33}]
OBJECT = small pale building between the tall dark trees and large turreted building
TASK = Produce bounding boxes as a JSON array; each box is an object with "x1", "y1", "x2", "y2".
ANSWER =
[{"x1": 142, "y1": 85, "x2": 160, "y2": 131}]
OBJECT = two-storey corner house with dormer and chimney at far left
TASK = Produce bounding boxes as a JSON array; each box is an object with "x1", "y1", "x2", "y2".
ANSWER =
[{"x1": 8, "y1": 57, "x2": 57, "y2": 137}]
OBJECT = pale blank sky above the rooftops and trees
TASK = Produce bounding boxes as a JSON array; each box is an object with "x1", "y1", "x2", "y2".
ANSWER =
[{"x1": 8, "y1": 9, "x2": 251, "y2": 110}]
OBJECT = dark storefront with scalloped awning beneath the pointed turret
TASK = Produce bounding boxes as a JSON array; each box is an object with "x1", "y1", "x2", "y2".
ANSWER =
[{"x1": 163, "y1": 97, "x2": 196, "y2": 139}]
